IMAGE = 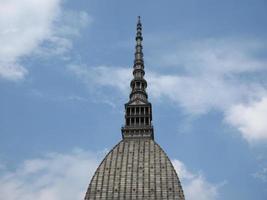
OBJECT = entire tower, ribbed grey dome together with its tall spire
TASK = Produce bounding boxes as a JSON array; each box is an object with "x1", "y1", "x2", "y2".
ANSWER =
[{"x1": 85, "y1": 17, "x2": 184, "y2": 200}]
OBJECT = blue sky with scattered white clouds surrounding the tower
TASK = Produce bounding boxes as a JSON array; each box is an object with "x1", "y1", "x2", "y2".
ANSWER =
[{"x1": 0, "y1": 0, "x2": 267, "y2": 200}]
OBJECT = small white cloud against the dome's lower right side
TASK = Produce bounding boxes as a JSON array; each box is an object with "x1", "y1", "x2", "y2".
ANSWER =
[{"x1": 172, "y1": 160, "x2": 221, "y2": 200}]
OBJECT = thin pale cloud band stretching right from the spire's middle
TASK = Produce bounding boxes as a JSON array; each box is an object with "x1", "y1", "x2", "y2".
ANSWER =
[{"x1": 148, "y1": 73, "x2": 247, "y2": 114}]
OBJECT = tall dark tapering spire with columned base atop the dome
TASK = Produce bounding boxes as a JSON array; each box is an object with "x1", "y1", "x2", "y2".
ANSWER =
[{"x1": 122, "y1": 16, "x2": 154, "y2": 139}]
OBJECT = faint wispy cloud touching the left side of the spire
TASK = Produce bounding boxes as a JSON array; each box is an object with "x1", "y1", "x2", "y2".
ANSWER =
[{"x1": 68, "y1": 65, "x2": 132, "y2": 108}]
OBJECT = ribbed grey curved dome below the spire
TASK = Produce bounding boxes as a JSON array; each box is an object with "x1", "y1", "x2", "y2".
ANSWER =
[{"x1": 85, "y1": 139, "x2": 184, "y2": 200}]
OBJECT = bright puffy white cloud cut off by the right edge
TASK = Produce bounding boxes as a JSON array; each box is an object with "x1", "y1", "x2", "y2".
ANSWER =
[{"x1": 226, "y1": 97, "x2": 267, "y2": 142}]
